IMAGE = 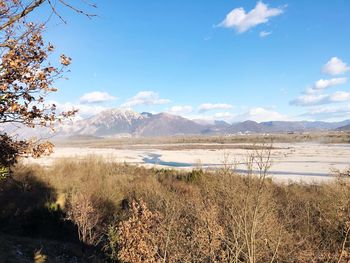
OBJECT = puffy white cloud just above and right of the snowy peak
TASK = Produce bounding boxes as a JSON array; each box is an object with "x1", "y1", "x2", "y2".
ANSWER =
[{"x1": 121, "y1": 91, "x2": 170, "y2": 107}]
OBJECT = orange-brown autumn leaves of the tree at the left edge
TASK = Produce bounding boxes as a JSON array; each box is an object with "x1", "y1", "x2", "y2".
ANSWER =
[{"x1": 0, "y1": 0, "x2": 76, "y2": 172}]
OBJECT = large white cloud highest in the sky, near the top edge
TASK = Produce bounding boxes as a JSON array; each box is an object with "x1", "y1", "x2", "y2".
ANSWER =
[{"x1": 218, "y1": 2, "x2": 283, "y2": 33}]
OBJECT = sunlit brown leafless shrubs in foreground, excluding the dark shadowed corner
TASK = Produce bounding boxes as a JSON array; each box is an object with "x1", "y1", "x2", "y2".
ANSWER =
[{"x1": 8, "y1": 157, "x2": 350, "y2": 262}]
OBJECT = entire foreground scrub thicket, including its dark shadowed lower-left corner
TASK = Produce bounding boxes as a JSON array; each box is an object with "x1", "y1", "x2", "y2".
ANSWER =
[{"x1": 0, "y1": 156, "x2": 350, "y2": 262}]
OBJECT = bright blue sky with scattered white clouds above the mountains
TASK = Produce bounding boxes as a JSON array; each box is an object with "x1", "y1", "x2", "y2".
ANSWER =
[{"x1": 35, "y1": 0, "x2": 350, "y2": 122}]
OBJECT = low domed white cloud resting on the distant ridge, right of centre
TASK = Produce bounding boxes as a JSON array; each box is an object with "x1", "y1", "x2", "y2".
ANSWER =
[{"x1": 234, "y1": 107, "x2": 288, "y2": 122}]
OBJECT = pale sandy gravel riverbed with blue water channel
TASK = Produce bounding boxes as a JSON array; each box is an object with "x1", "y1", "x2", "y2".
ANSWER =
[{"x1": 26, "y1": 143, "x2": 350, "y2": 183}]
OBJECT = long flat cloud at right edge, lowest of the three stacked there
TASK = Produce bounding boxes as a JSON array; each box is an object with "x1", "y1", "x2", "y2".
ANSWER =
[{"x1": 290, "y1": 91, "x2": 350, "y2": 106}]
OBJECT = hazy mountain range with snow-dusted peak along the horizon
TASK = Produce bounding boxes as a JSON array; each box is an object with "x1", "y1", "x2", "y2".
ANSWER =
[{"x1": 54, "y1": 109, "x2": 350, "y2": 137}]
